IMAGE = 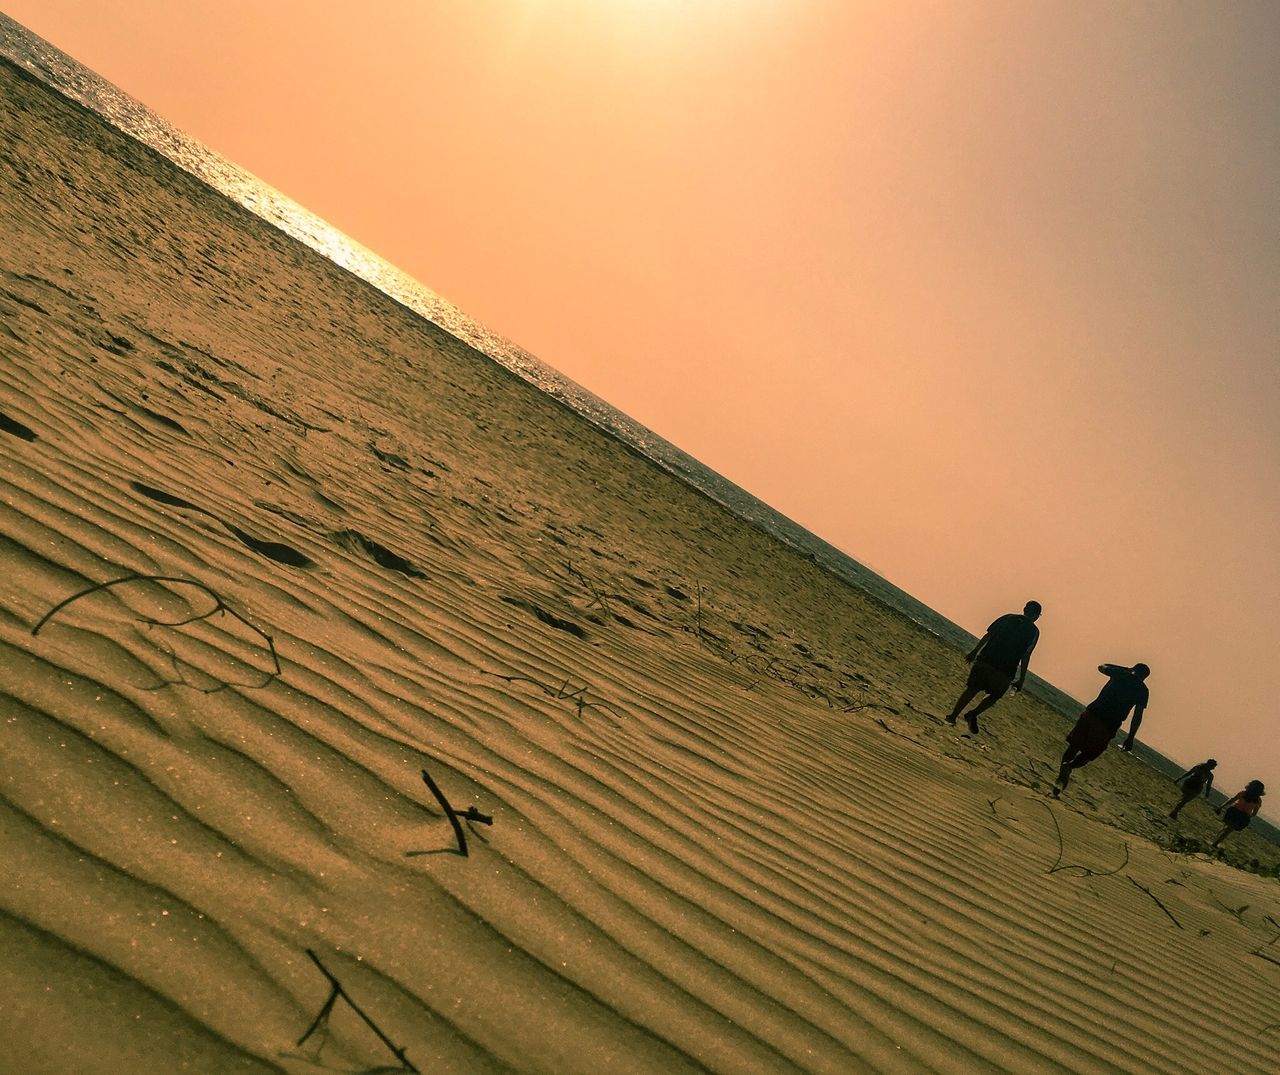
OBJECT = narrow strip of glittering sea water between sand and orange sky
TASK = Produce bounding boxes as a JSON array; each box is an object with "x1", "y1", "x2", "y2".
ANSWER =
[{"x1": 0, "y1": 13, "x2": 1085, "y2": 721}]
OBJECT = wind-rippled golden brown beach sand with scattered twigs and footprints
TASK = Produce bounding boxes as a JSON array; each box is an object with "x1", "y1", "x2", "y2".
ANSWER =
[{"x1": 0, "y1": 65, "x2": 1280, "y2": 1075}]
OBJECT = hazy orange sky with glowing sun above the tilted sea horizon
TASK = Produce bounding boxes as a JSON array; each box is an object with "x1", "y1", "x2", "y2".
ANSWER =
[{"x1": 0, "y1": 0, "x2": 1280, "y2": 798}]
